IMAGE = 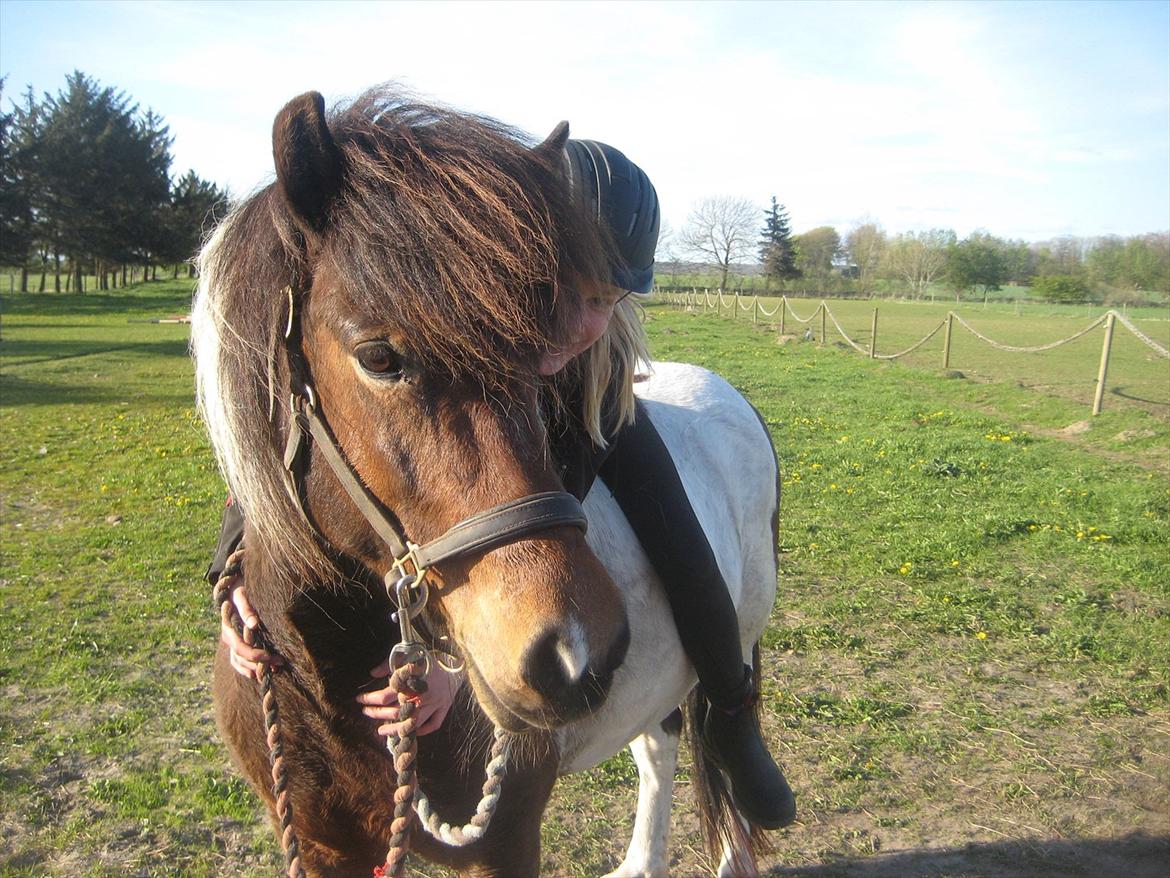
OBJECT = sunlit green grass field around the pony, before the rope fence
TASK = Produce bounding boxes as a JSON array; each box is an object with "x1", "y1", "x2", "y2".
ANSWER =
[{"x1": 0, "y1": 282, "x2": 1170, "y2": 878}]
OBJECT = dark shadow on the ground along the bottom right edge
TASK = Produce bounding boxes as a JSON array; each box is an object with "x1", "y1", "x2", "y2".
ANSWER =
[{"x1": 768, "y1": 832, "x2": 1170, "y2": 878}]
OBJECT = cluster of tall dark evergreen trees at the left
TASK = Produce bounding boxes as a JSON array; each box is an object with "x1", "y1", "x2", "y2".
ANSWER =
[{"x1": 0, "y1": 71, "x2": 227, "y2": 293}]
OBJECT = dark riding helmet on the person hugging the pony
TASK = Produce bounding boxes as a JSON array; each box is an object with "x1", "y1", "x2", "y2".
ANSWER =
[{"x1": 565, "y1": 140, "x2": 659, "y2": 293}]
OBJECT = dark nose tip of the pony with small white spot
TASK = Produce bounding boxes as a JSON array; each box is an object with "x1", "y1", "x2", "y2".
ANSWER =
[{"x1": 521, "y1": 620, "x2": 629, "y2": 722}]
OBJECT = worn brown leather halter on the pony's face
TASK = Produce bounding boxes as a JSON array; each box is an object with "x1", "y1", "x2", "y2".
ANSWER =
[{"x1": 274, "y1": 287, "x2": 589, "y2": 601}]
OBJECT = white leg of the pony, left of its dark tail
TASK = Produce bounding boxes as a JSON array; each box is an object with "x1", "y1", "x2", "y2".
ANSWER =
[{"x1": 605, "y1": 711, "x2": 682, "y2": 878}]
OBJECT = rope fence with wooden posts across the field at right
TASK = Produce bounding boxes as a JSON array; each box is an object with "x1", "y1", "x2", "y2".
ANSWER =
[{"x1": 661, "y1": 289, "x2": 1170, "y2": 414}]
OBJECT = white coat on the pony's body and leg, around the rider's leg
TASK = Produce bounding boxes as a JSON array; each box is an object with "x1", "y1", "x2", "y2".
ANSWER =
[{"x1": 557, "y1": 363, "x2": 777, "y2": 878}]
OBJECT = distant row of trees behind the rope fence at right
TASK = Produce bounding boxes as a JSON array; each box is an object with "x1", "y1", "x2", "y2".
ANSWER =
[{"x1": 660, "y1": 196, "x2": 1170, "y2": 302}]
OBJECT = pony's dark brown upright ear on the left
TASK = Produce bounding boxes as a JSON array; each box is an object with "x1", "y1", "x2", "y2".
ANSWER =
[{"x1": 273, "y1": 91, "x2": 342, "y2": 235}]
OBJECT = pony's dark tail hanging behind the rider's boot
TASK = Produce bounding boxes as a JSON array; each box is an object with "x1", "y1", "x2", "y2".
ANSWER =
[{"x1": 686, "y1": 644, "x2": 772, "y2": 874}]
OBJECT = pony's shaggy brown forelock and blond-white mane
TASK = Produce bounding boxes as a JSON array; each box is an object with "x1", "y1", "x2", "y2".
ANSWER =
[{"x1": 192, "y1": 87, "x2": 622, "y2": 577}]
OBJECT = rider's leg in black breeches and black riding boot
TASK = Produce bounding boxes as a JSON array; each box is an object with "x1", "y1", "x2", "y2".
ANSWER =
[{"x1": 586, "y1": 405, "x2": 796, "y2": 829}]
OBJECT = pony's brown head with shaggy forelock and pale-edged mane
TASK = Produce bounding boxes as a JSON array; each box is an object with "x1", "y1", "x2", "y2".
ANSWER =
[{"x1": 193, "y1": 89, "x2": 628, "y2": 728}]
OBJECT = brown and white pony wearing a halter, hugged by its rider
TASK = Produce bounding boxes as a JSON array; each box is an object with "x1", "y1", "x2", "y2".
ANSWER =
[{"x1": 192, "y1": 90, "x2": 778, "y2": 878}]
